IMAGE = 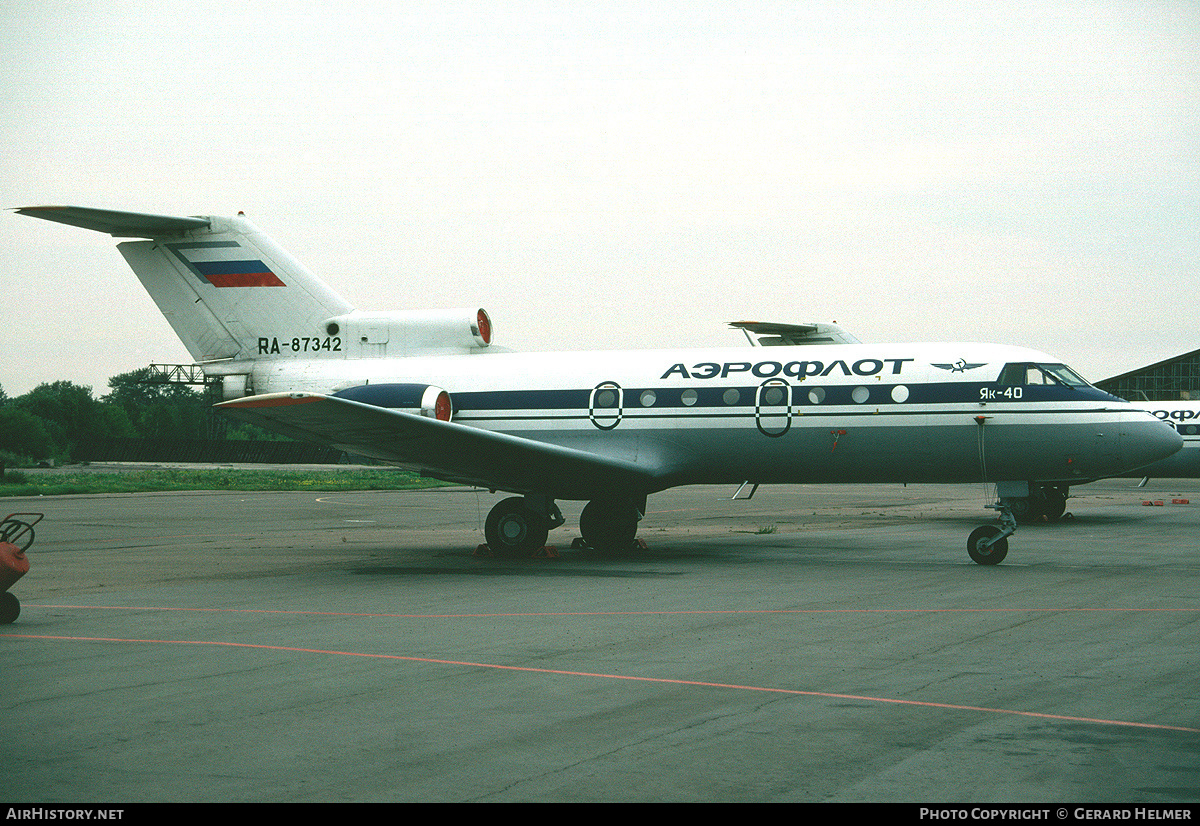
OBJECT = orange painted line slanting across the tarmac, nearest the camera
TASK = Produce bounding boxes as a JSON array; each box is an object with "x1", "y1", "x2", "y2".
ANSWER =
[{"x1": 0, "y1": 634, "x2": 1200, "y2": 734}]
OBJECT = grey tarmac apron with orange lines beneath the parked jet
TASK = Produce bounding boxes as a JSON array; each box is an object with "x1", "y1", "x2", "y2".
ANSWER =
[{"x1": 0, "y1": 480, "x2": 1200, "y2": 801}]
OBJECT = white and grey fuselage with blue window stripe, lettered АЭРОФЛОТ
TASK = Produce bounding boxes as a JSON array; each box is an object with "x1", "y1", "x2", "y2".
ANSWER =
[{"x1": 209, "y1": 343, "x2": 1178, "y2": 492}]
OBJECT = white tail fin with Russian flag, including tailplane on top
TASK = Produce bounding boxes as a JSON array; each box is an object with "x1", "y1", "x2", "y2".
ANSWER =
[{"x1": 17, "y1": 207, "x2": 353, "y2": 363}]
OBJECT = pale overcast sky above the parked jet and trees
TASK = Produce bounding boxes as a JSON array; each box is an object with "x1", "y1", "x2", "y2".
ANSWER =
[{"x1": 0, "y1": 0, "x2": 1200, "y2": 396}]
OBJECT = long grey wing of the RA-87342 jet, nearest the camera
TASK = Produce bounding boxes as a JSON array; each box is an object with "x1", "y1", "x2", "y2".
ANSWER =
[{"x1": 217, "y1": 393, "x2": 654, "y2": 499}]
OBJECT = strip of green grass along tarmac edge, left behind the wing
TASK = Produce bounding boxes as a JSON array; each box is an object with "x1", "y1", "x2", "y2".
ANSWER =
[{"x1": 0, "y1": 467, "x2": 445, "y2": 496}]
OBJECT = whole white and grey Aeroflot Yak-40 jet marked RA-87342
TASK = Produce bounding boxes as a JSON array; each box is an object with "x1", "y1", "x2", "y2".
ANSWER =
[{"x1": 17, "y1": 207, "x2": 1181, "y2": 564}]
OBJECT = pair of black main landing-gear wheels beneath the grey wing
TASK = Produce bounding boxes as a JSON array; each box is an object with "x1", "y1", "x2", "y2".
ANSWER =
[{"x1": 484, "y1": 496, "x2": 646, "y2": 557}]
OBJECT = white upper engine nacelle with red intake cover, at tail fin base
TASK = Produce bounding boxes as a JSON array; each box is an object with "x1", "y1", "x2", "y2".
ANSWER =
[{"x1": 322, "y1": 309, "x2": 492, "y2": 358}]
